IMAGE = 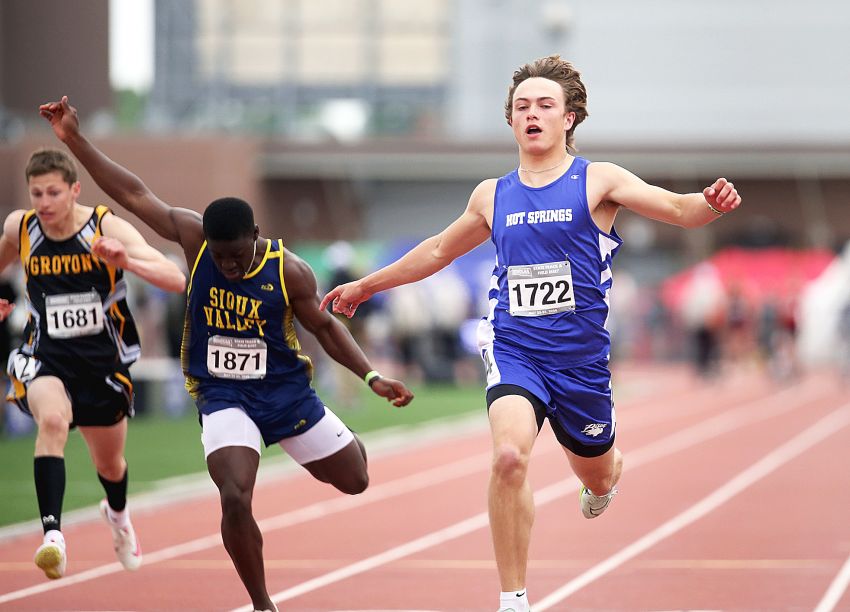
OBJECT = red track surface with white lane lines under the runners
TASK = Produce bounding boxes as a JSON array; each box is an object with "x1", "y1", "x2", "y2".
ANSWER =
[{"x1": 0, "y1": 368, "x2": 850, "y2": 612}]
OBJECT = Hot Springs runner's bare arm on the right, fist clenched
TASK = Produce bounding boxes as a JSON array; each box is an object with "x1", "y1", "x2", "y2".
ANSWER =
[{"x1": 587, "y1": 162, "x2": 741, "y2": 227}]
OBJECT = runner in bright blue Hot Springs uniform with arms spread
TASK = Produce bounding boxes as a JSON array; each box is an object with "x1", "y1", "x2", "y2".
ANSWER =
[{"x1": 321, "y1": 56, "x2": 741, "y2": 612}]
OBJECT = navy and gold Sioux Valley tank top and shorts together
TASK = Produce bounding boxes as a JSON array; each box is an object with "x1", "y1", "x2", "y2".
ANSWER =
[{"x1": 182, "y1": 235, "x2": 330, "y2": 446}]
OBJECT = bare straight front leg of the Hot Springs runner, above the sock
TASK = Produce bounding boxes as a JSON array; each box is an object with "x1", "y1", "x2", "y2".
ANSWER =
[{"x1": 488, "y1": 395, "x2": 538, "y2": 591}]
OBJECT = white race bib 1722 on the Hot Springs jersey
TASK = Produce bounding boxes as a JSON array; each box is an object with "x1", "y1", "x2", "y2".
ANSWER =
[{"x1": 508, "y1": 261, "x2": 576, "y2": 317}]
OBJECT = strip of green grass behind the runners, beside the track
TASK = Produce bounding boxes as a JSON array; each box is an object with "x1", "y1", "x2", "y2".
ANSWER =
[{"x1": 0, "y1": 385, "x2": 484, "y2": 526}]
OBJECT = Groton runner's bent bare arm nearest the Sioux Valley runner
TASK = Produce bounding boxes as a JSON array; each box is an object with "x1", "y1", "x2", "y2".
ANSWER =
[{"x1": 97, "y1": 215, "x2": 186, "y2": 293}]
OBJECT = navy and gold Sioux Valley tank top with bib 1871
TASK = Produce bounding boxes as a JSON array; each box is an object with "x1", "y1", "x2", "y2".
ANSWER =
[{"x1": 181, "y1": 240, "x2": 313, "y2": 399}]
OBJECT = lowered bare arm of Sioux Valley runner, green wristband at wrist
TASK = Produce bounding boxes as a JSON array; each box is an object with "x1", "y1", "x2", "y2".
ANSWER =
[{"x1": 285, "y1": 251, "x2": 413, "y2": 406}]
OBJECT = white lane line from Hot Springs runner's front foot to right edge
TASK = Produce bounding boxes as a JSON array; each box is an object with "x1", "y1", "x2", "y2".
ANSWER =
[{"x1": 534, "y1": 405, "x2": 850, "y2": 612}]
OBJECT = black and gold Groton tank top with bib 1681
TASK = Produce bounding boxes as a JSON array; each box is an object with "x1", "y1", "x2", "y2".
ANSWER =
[{"x1": 19, "y1": 206, "x2": 141, "y2": 373}]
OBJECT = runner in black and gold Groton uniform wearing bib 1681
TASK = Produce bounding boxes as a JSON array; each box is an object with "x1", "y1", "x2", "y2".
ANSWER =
[{"x1": 0, "y1": 150, "x2": 185, "y2": 578}]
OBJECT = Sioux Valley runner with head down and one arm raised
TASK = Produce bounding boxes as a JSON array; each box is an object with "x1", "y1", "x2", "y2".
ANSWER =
[{"x1": 40, "y1": 97, "x2": 413, "y2": 610}]
